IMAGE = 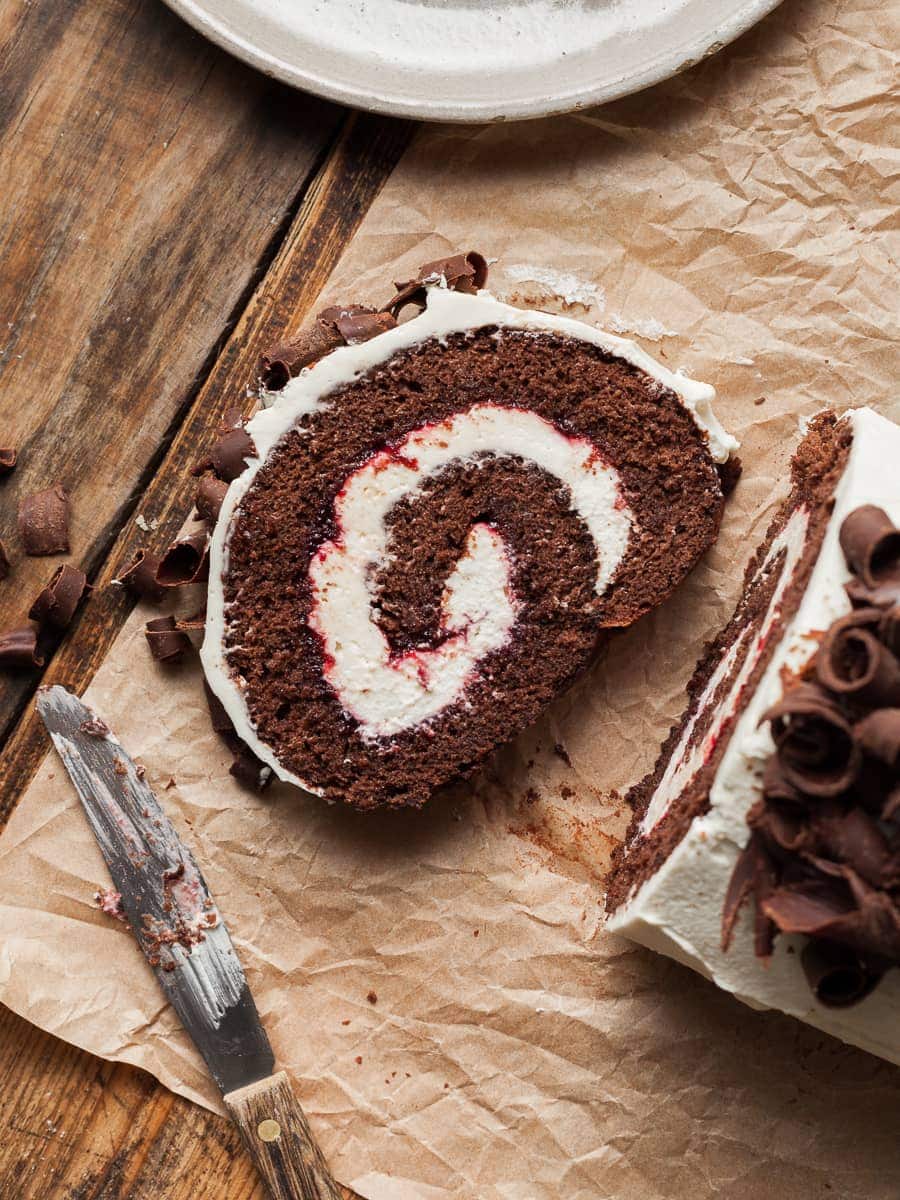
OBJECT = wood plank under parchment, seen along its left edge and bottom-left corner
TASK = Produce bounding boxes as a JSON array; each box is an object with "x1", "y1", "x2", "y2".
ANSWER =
[{"x1": 0, "y1": 91, "x2": 410, "y2": 1200}]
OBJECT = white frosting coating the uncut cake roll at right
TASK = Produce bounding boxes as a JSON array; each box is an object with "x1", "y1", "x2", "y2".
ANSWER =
[{"x1": 608, "y1": 408, "x2": 900, "y2": 1063}]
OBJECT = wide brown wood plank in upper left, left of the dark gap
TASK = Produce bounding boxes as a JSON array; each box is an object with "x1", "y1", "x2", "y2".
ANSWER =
[{"x1": 0, "y1": 0, "x2": 343, "y2": 736}]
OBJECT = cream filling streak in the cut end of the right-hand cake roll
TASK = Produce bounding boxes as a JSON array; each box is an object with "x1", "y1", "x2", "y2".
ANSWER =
[{"x1": 641, "y1": 508, "x2": 809, "y2": 834}]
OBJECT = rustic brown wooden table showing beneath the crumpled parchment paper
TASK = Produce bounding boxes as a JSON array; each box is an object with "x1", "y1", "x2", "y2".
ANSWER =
[{"x1": 0, "y1": 0, "x2": 413, "y2": 1200}]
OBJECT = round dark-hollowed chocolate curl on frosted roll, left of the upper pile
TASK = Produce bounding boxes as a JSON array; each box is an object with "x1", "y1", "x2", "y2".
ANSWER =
[{"x1": 762, "y1": 683, "x2": 863, "y2": 797}]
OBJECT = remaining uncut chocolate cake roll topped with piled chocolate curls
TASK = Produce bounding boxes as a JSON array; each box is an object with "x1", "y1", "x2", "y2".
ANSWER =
[{"x1": 607, "y1": 408, "x2": 900, "y2": 1062}]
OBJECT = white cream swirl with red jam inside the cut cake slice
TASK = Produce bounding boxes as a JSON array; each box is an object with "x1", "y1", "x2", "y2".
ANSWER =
[{"x1": 310, "y1": 404, "x2": 635, "y2": 740}]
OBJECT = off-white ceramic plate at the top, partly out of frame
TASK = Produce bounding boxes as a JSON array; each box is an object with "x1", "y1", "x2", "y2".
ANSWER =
[{"x1": 167, "y1": 0, "x2": 779, "y2": 121}]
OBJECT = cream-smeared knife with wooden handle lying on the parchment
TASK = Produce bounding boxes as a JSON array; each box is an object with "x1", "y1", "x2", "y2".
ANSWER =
[{"x1": 37, "y1": 685, "x2": 343, "y2": 1200}]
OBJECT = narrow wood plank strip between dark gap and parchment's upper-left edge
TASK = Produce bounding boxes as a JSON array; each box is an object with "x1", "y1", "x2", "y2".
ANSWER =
[{"x1": 0, "y1": 108, "x2": 410, "y2": 820}]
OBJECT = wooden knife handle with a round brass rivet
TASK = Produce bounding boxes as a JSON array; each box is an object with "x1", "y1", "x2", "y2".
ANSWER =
[{"x1": 224, "y1": 1070, "x2": 348, "y2": 1200}]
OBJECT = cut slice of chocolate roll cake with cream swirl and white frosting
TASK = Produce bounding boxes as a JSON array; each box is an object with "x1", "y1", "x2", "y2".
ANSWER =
[{"x1": 203, "y1": 262, "x2": 734, "y2": 808}]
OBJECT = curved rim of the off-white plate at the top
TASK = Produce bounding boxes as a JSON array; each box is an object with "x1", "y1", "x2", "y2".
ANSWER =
[{"x1": 164, "y1": 0, "x2": 782, "y2": 125}]
